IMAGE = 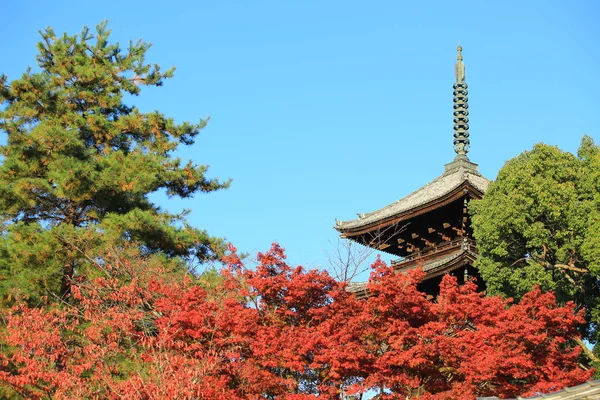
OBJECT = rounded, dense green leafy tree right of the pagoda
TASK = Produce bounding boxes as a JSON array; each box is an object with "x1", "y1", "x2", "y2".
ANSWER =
[{"x1": 471, "y1": 136, "x2": 600, "y2": 354}]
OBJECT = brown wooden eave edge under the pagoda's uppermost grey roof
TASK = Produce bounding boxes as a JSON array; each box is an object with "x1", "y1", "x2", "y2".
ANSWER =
[{"x1": 334, "y1": 180, "x2": 483, "y2": 238}]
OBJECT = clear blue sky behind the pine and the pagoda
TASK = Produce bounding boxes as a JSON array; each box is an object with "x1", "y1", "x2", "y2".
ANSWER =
[{"x1": 0, "y1": 0, "x2": 600, "y2": 276}]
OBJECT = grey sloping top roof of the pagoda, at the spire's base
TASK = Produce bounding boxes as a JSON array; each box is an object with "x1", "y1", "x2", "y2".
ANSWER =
[{"x1": 335, "y1": 162, "x2": 490, "y2": 231}]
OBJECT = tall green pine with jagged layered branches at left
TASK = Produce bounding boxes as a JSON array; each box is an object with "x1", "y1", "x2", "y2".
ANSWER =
[{"x1": 0, "y1": 22, "x2": 229, "y2": 301}]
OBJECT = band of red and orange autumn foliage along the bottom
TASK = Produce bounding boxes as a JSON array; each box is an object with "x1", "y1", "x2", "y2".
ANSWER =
[{"x1": 0, "y1": 245, "x2": 592, "y2": 399}]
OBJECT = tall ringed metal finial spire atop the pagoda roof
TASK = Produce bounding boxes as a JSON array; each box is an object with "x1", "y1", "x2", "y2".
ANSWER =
[{"x1": 453, "y1": 43, "x2": 470, "y2": 160}]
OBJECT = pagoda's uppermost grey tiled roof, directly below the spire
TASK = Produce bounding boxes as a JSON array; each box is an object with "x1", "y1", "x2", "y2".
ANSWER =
[{"x1": 335, "y1": 157, "x2": 490, "y2": 234}]
